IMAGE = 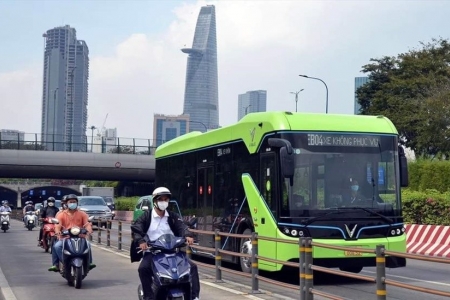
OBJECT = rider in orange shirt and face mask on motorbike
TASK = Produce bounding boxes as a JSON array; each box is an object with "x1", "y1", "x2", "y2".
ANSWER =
[{"x1": 48, "y1": 194, "x2": 96, "y2": 272}]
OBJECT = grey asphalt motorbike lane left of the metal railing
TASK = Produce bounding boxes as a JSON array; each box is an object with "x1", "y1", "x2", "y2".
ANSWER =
[{"x1": 0, "y1": 220, "x2": 294, "y2": 300}]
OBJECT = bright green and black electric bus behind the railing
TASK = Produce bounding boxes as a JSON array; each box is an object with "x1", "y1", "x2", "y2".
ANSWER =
[{"x1": 155, "y1": 112, "x2": 408, "y2": 273}]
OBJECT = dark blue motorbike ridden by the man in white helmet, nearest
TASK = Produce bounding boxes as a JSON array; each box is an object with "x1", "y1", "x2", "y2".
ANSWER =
[{"x1": 138, "y1": 234, "x2": 192, "y2": 300}]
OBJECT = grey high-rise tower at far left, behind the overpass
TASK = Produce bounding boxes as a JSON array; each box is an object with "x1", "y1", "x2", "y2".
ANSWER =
[{"x1": 41, "y1": 25, "x2": 89, "y2": 151}]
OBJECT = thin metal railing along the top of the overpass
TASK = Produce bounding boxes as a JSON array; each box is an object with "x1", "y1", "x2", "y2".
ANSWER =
[{"x1": 0, "y1": 132, "x2": 165, "y2": 155}]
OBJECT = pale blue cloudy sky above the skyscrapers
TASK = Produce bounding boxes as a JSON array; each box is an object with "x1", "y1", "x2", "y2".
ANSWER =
[{"x1": 0, "y1": 0, "x2": 450, "y2": 138}]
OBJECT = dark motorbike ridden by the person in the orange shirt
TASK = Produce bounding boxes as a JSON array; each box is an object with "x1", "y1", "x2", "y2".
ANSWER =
[{"x1": 59, "y1": 226, "x2": 91, "y2": 289}]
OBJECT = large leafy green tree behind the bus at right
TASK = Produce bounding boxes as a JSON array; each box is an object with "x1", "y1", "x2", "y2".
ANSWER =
[{"x1": 356, "y1": 38, "x2": 450, "y2": 157}]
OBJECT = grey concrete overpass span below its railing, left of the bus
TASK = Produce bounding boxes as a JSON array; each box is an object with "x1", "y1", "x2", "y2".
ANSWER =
[{"x1": 0, "y1": 149, "x2": 155, "y2": 182}]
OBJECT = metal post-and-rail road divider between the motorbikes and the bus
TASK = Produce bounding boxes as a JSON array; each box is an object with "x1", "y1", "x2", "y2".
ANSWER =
[{"x1": 13, "y1": 213, "x2": 450, "y2": 300}]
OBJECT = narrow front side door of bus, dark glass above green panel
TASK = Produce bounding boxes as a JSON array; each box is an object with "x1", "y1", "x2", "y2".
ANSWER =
[{"x1": 260, "y1": 153, "x2": 280, "y2": 267}]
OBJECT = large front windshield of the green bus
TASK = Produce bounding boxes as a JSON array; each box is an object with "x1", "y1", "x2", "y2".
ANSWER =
[{"x1": 280, "y1": 132, "x2": 401, "y2": 218}]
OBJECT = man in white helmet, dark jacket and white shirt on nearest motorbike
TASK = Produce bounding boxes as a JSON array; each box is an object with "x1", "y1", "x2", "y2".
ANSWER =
[{"x1": 131, "y1": 187, "x2": 200, "y2": 300}]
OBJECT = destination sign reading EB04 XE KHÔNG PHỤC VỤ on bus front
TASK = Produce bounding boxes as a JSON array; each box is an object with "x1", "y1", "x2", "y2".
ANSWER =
[{"x1": 308, "y1": 133, "x2": 380, "y2": 147}]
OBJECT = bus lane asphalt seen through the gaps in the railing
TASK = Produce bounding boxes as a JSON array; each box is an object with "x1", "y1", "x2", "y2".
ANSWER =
[{"x1": 99, "y1": 221, "x2": 450, "y2": 300}]
